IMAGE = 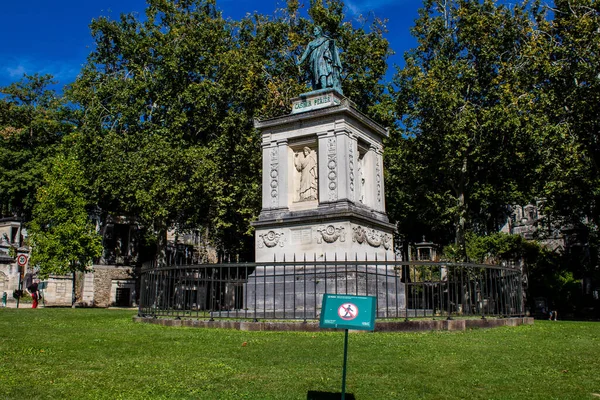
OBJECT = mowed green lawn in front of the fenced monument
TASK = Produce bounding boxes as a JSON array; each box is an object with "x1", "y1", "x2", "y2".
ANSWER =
[{"x1": 0, "y1": 309, "x2": 600, "y2": 400}]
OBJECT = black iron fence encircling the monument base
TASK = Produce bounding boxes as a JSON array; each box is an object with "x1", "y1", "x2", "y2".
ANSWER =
[{"x1": 139, "y1": 261, "x2": 524, "y2": 320}]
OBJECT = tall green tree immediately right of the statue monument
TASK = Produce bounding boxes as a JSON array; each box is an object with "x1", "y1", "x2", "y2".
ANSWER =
[{"x1": 387, "y1": 0, "x2": 538, "y2": 258}]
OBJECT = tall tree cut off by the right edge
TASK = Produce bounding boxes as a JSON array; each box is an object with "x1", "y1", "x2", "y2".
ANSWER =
[{"x1": 535, "y1": 0, "x2": 600, "y2": 277}]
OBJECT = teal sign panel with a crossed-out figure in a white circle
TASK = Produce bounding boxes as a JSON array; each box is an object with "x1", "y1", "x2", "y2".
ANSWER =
[{"x1": 319, "y1": 293, "x2": 377, "y2": 331}]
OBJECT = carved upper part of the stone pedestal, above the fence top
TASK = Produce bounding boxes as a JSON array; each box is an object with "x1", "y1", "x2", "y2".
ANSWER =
[{"x1": 254, "y1": 89, "x2": 394, "y2": 262}]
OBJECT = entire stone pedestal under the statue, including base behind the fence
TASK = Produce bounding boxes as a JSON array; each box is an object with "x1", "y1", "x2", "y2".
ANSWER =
[{"x1": 245, "y1": 89, "x2": 404, "y2": 316}]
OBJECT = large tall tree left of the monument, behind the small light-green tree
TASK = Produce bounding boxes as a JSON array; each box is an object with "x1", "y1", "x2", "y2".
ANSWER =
[{"x1": 70, "y1": 1, "x2": 248, "y2": 260}]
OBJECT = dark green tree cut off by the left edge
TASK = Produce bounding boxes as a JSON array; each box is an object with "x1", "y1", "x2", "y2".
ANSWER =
[{"x1": 0, "y1": 74, "x2": 74, "y2": 221}]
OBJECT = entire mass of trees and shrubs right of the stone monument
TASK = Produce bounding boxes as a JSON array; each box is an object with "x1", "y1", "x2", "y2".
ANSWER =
[{"x1": 387, "y1": 0, "x2": 600, "y2": 310}]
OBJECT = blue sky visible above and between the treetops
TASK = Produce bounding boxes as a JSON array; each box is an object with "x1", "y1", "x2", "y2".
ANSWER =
[{"x1": 0, "y1": 0, "x2": 421, "y2": 87}]
